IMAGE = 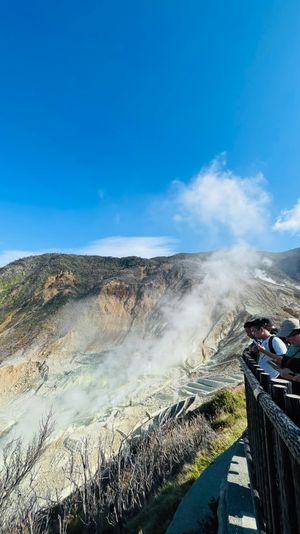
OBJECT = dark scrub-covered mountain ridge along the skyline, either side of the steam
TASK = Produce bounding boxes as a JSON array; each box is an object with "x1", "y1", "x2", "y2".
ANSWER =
[{"x1": 0, "y1": 248, "x2": 300, "y2": 368}]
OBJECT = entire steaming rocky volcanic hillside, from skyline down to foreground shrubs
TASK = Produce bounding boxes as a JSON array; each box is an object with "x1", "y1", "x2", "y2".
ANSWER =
[{"x1": 0, "y1": 247, "x2": 300, "y2": 516}]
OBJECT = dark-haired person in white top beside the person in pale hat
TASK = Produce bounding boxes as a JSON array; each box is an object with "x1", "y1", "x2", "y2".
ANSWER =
[{"x1": 252, "y1": 318, "x2": 287, "y2": 378}]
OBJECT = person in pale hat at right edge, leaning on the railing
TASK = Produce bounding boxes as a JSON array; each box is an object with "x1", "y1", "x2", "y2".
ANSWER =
[{"x1": 253, "y1": 317, "x2": 300, "y2": 382}]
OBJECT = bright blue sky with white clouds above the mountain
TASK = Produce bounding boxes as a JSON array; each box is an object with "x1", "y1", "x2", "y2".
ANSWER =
[{"x1": 0, "y1": 0, "x2": 300, "y2": 264}]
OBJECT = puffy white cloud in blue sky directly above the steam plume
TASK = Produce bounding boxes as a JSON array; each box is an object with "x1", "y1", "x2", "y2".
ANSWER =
[{"x1": 176, "y1": 157, "x2": 270, "y2": 238}]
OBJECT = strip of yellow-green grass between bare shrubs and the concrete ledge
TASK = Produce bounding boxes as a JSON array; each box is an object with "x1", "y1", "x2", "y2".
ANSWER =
[{"x1": 125, "y1": 387, "x2": 247, "y2": 534}]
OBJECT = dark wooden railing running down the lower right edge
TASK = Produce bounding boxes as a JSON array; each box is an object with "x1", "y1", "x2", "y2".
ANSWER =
[{"x1": 241, "y1": 355, "x2": 300, "y2": 534}]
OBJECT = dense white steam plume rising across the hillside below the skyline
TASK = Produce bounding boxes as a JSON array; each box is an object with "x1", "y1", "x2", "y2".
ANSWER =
[{"x1": 144, "y1": 245, "x2": 257, "y2": 371}]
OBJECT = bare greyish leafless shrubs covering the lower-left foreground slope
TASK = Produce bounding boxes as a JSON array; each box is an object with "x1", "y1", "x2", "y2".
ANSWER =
[{"x1": 0, "y1": 415, "x2": 214, "y2": 534}]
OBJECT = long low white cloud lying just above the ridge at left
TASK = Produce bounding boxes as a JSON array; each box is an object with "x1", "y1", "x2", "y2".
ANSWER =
[{"x1": 0, "y1": 236, "x2": 177, "y2": 267}]
